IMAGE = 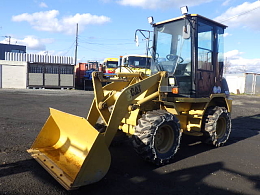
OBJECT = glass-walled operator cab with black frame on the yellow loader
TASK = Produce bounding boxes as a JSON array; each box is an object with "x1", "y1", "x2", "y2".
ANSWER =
[{"x1": 151, "y1": 14, "x2": 226, "y2": 97}]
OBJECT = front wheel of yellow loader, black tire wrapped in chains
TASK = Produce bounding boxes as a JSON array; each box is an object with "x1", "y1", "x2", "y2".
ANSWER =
[{"x1": 133, "y1": 110, "x2": 181, "y2": 165}]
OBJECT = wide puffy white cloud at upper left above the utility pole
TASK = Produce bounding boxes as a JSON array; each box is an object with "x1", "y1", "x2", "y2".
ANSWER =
[{"x1": 12, "y1": 10, "x2": 110, "y2": 34}]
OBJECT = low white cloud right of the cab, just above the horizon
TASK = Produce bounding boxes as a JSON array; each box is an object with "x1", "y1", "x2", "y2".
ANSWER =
[{"x1": 225, "y1": 50, "x2": 260, "y2": 73}]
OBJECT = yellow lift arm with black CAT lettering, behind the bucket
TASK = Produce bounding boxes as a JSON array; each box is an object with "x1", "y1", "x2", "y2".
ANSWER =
[{"x1": 87, "y1": 72, "x2": 162, "y2": 147}]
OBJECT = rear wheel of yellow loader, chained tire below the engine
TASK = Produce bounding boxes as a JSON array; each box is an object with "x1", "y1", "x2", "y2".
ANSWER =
[{"x1": 202, "y1": 106, "x2": 231, "y2": 147}]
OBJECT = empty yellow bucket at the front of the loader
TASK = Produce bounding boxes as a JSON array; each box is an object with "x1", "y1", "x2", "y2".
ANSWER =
[{"x1": 28, "y1": 108, "x2": 111, "y2": 190}]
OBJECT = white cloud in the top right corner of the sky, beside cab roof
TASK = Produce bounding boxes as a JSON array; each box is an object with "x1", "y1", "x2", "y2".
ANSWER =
[{"x1": 214, "y1": 1, "x2": 260, "y2": 30}]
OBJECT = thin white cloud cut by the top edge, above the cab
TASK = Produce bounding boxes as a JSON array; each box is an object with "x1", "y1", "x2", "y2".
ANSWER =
[{"x1": 117, "y1": 0, "x2": 212, "y2": 9}]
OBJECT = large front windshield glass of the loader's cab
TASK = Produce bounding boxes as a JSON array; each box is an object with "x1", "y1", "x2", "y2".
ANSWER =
[{"x1": 151, "y1": 20, "x2": 191, "y2": 76}]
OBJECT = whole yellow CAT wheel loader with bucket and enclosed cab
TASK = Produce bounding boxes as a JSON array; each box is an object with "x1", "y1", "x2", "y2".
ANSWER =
[{"x1": 28, "y1": 14, "x2": 232, "y2": 190}]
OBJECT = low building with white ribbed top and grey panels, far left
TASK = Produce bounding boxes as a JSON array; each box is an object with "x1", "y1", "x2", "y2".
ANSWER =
[{"x1": 0, "y1": 52, "x2": 75, "y2": 89}]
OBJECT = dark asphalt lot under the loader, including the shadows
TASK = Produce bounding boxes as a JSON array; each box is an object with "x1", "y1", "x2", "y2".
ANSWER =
[{"x1": 0, "y1": 89, "x2": 260, "y2": 195}]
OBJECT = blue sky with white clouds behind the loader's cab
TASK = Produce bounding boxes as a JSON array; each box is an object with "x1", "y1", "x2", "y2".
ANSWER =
[{"x1": 0, "y1": 0, "x2": 260, "y2": 72}]
